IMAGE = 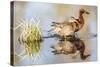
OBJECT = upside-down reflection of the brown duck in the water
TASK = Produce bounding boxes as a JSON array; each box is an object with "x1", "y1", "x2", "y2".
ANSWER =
[{"x1": 51, "y1": 37, "x2": 90, "y2": 60}]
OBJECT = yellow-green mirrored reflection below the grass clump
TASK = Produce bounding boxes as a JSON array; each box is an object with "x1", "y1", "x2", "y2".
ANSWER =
[{"x1": 24, "y1": 41, "x2": 41, "y2": 56}]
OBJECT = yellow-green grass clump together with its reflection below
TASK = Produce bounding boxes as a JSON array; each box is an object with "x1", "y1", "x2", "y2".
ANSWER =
[{"x1": 21, "y1": 17, "x2": 43, "y2": 55}]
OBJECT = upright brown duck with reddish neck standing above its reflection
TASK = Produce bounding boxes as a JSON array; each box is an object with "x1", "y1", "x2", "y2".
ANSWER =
[{"x1": 51, "y1": 8, "x2": 90, "y2": 39}]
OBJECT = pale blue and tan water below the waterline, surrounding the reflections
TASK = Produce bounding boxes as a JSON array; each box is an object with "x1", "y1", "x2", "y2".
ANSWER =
[{"x1": 15, "y1": 35, "x2": 97, "y2": 65}]
